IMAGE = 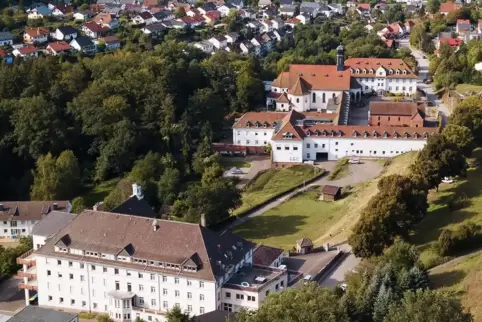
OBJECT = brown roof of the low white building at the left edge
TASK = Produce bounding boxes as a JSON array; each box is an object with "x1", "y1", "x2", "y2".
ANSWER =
[{"x1": 0, "y1": 201, "x2": 70, "y2": 220}]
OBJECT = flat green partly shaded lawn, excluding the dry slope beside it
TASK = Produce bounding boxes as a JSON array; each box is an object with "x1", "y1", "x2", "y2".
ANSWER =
[{"x1": 234, "y1": 188, "x2": 348, "y2": 250}]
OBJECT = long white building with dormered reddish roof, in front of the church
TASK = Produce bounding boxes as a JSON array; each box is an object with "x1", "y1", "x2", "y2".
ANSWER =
[{"x1": 233, "y1": 110, "x2": 439, "y2": 166}]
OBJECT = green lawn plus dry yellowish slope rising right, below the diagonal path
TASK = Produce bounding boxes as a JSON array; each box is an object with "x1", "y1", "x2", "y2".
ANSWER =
[{"x1": 235, "y1": 153, "x2": 415, "y2": 249}]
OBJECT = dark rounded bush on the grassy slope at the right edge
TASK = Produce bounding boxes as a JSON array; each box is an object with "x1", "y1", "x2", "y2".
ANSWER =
[{"x1": 437, "y1": 223, "x2": 482, "y2": 256}]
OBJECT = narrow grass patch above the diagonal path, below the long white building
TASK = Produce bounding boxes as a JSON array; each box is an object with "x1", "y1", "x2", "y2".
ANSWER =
[{"x1": 233, "y1": 165, "x2": 324, "y2": 215}]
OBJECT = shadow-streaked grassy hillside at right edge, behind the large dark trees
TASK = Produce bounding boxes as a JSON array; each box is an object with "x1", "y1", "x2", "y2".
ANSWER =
[{"x1": 410, "y1": 150, "x2": 482, "y2": 267}]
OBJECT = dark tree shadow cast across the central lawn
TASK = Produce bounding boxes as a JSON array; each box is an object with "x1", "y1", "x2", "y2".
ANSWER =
[{"x1": 234, "y1": 215, "x2": 306, "y2": 240}]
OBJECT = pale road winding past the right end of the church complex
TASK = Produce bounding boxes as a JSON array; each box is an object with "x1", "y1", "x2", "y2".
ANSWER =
[{"x1": 400, "y1": 39, "x2": 450, "y2": 125}]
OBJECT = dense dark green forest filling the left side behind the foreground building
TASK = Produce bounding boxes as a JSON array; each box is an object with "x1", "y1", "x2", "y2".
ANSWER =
[{"x1": 0, "y1": 22, "x2": 416, "y2": 221}]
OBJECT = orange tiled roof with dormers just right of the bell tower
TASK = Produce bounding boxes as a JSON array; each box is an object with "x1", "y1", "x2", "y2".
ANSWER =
[{"x1": 345, "y1": 58, "x2": 418, "y2": 78}]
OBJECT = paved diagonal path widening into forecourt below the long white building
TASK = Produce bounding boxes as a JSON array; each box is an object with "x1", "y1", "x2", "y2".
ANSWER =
[{"x1": 226, "y1": 160, "x2": 383, "y2": 229}]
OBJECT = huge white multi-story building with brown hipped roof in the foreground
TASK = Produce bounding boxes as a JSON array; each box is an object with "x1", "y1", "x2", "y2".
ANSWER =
[{"x1": 17, "y1": 210, "x2": 288, "y2": 322}]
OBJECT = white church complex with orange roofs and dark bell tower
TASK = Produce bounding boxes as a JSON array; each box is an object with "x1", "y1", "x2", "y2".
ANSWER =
[{"x1": 267, "y1": 46, "x2": 417, "y2": 113}]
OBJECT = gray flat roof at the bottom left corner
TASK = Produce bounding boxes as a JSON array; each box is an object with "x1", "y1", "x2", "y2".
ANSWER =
[{"x1": 8, "y1": 305, "x2": 78, "y2": 322}]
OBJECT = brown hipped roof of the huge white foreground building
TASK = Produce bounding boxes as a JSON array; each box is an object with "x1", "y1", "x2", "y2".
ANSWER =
[{"x1": 35, "y1": 210, "x2": 253, "y2": 281}]
